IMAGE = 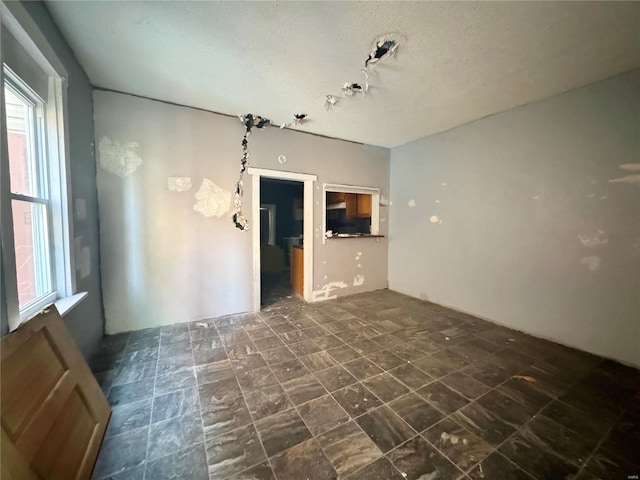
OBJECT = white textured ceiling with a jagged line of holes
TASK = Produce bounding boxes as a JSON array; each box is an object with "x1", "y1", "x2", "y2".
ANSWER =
[{"x1": 47, "y1": 1, "x2": 640, "y2": 147}]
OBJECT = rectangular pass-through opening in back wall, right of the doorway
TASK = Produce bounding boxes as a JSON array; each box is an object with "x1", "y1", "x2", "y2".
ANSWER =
[{"x1": 323, "y1": 184, "x2": 380, "y2": 242}]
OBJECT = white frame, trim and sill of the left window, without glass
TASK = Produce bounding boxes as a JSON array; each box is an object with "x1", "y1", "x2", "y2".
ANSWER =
[{"x1": 0, "y1": 2, "x2": 82, "y2": 331}]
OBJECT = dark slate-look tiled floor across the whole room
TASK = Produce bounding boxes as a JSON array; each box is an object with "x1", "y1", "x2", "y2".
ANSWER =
[{"x1": 91, "y1": 291, "x2": 640, "y2": 480}]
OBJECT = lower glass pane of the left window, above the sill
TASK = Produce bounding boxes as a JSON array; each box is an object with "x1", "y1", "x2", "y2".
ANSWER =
[{"x1": 11, "y1": 200, "x2": 53, "y2": 309}]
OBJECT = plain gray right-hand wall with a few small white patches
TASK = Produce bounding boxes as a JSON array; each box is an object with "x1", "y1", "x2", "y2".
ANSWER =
[{"x1": 389, "y1": 70, "x2": 640, "y2": 365}]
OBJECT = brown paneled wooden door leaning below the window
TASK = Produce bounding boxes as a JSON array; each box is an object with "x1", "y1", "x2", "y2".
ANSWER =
[{"x1": 0, "y1": 307, "x2": 111, "y2": 480}]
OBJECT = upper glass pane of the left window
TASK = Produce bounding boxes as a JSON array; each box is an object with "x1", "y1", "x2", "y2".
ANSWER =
[{"x1": 4, "y1": 86, "x2": 38, "y2": 196}]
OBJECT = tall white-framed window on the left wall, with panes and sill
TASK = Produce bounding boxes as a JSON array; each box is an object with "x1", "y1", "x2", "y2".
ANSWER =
[{"x1": 0, "y1": 2, "x2": 80, "y2": 331}]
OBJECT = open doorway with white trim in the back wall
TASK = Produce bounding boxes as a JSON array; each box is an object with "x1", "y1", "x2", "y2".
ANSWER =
[{"x1": 248, "y1": 168, "x2": 317, "y2": 311}]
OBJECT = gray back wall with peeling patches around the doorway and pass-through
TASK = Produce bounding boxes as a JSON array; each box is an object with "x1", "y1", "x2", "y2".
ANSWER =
[{"x1": 94, "y1": 91, "x2": 389, "y2": 333}]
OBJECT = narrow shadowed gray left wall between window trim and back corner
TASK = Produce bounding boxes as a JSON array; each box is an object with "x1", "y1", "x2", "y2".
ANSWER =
[{"x1": 5, "y1": 2, "x2": 104, "y2": 356}]
